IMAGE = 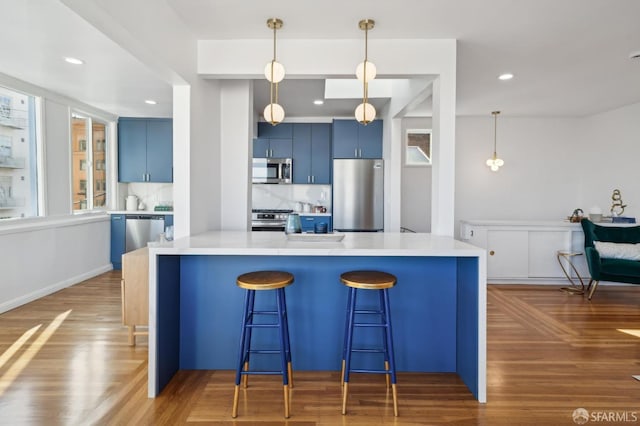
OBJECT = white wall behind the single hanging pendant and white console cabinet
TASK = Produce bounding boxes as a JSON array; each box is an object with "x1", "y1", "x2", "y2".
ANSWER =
[{"x1": 456, "y1": 104, "x2": 640, "y2": 235}]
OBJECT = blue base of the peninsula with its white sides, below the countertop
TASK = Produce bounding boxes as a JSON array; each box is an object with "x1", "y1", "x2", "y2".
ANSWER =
[{"x1": 149, "y1": 254, "x2": 486, "y2": 402}]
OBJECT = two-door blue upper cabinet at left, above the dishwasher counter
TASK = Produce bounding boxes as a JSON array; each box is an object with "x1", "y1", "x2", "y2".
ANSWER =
[{"x1": 118, "y1": 118, "x2": 173, "y2": 182}]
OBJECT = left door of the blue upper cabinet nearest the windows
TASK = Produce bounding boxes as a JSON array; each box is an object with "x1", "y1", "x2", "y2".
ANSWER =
[{"x1": 118, "y1": 119, "x2": 147, "y2": 182}]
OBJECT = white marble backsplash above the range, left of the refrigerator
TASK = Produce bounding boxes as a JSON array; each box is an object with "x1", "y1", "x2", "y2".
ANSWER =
[{"x1": 252, "y1": 184, "x2": 331, "y2": 212}]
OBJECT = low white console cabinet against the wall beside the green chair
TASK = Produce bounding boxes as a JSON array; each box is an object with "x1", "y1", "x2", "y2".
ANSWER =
[{"x1": 460, "y1": 220, "x2": 589, "y2": 284}]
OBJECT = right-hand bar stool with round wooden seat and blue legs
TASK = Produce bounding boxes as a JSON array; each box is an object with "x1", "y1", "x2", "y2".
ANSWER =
[{"x1": 340, "y1": 271, "x2": 398, "y2": 417}]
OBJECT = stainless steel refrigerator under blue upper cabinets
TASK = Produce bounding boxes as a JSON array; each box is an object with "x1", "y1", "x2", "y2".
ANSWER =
[{"x1": 333, "y1": 159, "x2": 384, "y2": 231}]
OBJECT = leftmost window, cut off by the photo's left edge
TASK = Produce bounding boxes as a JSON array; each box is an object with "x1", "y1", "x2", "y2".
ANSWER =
[{"x1": 0, "y1": 87, "x2": 40, "y2": 219}]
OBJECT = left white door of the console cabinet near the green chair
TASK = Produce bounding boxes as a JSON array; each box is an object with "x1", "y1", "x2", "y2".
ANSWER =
[{"x1": 487, "y1": 230, "x2": 529, "y2": 278}]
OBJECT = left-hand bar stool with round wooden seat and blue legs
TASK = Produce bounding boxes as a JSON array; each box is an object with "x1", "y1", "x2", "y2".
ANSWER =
[{"x1": 231, "y1": 271, "x2": 293, "y2": 418}]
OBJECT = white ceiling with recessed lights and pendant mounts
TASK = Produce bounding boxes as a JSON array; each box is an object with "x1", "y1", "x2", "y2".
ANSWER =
[{"x1": 0, "y1": 0, "x2": 640, "y2": 117}]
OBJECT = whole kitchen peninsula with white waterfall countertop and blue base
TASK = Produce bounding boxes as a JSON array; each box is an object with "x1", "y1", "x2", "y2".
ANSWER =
[{"x1": 148, "y1": 231, "x2": 486, "y2": 402}]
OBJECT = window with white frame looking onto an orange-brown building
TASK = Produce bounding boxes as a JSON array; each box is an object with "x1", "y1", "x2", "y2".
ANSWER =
[{"x1": 71, "y1": 113, "x2": 107, "y2": 212}]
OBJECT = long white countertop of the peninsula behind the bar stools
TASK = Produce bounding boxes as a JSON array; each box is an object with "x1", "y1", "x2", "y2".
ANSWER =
[{"x1": 150, "y1": 231, "x2": 485, "y2": 258}]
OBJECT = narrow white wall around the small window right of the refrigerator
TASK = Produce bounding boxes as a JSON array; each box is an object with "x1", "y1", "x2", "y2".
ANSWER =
[{"x1": 401, "y1": 117, "x2": 432, "y2": 232}]
